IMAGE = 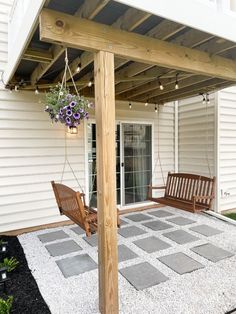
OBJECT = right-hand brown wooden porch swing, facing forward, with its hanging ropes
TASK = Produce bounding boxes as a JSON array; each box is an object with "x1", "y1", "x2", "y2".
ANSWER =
[{"x1": 147, "y1": 103, "x2": 215, "y2": 212}]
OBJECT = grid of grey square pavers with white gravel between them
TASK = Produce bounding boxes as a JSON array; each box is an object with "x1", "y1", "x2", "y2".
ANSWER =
[{"x1": 38, "y1": 209, "x2": 233, "y2": 290}]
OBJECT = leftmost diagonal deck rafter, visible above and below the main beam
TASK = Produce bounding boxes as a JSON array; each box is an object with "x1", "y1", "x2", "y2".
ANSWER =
[{"x1": 30, "y1": 0, "x2": 109, "y2": 85}]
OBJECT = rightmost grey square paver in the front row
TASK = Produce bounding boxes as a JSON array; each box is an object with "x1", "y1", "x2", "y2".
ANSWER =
[{"x1": 191, "y1": 243, "x2": 233, "y2": 262}]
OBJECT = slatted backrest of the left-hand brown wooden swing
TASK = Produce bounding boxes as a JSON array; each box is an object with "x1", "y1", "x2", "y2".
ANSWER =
[{"x1": 51, "y1": 181, "x2": 89, "y2": 230}]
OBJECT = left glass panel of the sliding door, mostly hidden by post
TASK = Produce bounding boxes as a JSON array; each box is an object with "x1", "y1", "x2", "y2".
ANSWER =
[{"x1": 87, "y1": 123, "x2": 120, "y2": 207}]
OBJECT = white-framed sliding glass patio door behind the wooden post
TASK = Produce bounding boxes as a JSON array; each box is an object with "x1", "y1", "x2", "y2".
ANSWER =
[{"x1": 87, "y1": 123, "x2": 152, "y2": 207}]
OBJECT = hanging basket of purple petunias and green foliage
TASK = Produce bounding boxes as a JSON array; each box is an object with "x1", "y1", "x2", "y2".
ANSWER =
[{"x1": 45, "y1": 84, "x2": 91, "y2": 127}]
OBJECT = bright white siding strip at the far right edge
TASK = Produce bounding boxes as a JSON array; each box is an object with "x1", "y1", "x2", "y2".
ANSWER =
[{"x1": 218, "y1": 87, "x2": 236, "y2": 211}]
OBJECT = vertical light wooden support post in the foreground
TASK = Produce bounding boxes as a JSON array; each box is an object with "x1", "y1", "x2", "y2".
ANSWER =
[{"x1": 94, "y1": 51, "x2": 118, "y2": 314}]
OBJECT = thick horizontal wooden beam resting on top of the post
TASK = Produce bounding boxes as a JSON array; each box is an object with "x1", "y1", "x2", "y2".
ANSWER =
[{"x1": 40, "y1": 9, "x2": 236, "y2": 81}]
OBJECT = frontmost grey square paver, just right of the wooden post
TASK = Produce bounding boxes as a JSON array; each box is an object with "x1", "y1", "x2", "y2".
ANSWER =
[{"x1": 120, "y1": 262, "x2": 168, "y2": 290}]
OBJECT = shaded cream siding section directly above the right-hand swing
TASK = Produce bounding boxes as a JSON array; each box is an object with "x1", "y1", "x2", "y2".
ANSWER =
[{"x1": 178, "y1": 95, "x2": 216, "y2": 176}]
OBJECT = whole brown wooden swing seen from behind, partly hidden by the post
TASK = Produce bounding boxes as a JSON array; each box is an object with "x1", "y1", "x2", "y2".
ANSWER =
[{"x1": 51, "y1": 181, "x2": 120, "y2": 237}]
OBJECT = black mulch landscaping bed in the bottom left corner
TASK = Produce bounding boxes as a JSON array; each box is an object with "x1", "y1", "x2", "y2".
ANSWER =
[{"x1": 0, "y1": 236, "x2": 51, "y2": 314}]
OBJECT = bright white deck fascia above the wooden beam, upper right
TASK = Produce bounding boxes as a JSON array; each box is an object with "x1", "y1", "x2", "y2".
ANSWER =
[{"x1": 115, "y1": 0, "x2": 236, "y2": 42}]
